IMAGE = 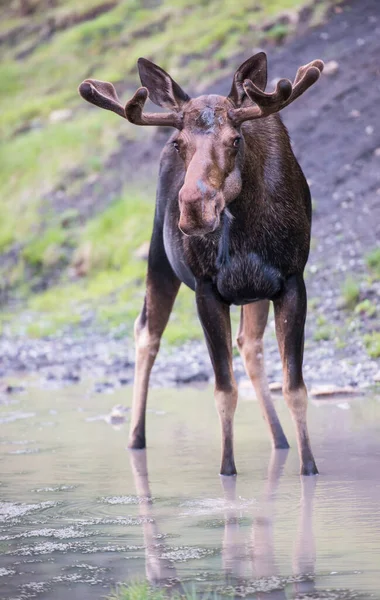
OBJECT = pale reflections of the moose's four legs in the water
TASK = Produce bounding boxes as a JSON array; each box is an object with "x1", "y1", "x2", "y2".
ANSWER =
[{"x1": 130, "y1": 450, "x2": 316, "y2": 600}]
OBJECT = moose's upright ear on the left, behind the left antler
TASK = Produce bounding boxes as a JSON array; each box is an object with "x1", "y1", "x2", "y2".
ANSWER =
[{"x1": 137, "y1": 58, "x2": 190, "y2": 111}]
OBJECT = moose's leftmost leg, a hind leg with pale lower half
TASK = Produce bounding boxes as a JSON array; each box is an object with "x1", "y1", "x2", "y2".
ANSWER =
[{"x1": 128, "y1": 254, "x2": 180, "y2": 448}]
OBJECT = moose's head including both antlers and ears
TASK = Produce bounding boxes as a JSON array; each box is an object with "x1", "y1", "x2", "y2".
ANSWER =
[{"x1": 79, "y1": 52, "x2": 323, "y2": 235}]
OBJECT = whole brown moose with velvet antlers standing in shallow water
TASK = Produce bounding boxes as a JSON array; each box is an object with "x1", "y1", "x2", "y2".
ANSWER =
[{"x1": 79, "y1": 52, "x2": 323, "y2": 475}]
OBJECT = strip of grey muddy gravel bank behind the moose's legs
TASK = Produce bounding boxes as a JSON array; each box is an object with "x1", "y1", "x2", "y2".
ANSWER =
[{"x1": 0, "y1": 323, "x2": 380, "y2": 392}]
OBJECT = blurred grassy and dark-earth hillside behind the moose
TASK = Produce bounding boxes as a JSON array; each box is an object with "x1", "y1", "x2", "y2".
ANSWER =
[{"x1": 0, "y1": 0, "x2": 380, "y2": 383}]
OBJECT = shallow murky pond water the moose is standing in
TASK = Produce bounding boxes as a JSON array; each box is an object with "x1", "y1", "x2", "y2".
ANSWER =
[{"x1": 0, "y1": 385, "x2": 380, "y2": 600}]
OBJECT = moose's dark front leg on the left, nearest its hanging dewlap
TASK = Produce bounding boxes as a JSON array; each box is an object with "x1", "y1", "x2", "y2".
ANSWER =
[{"x1": 196, "y1": 282, "x2": 238, "y2": 475}]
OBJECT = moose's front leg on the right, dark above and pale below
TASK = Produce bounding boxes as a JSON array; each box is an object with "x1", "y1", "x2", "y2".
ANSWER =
[{"x1": 274, "y1": 275, "x2": 318, "y2": 475}]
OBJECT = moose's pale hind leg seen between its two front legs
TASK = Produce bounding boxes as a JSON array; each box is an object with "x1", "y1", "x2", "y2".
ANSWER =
[{"x1": 236, "y1": 300, "x2": 289, "y2": 449}]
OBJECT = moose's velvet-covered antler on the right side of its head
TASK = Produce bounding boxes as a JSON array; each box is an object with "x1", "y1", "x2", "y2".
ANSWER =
[{"x1": 230, "y1": 60, "x2": 324, "y2": 124}]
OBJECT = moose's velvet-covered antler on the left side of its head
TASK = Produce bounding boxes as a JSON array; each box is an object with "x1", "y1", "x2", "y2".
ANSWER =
[{"x1": 79, "y1": 79, "x2": 182, "y2": 129}]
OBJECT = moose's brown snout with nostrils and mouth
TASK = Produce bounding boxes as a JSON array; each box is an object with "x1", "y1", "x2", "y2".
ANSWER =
[{"x1": 178, "y1": 188, "x2": 223, "y2": 235}]
